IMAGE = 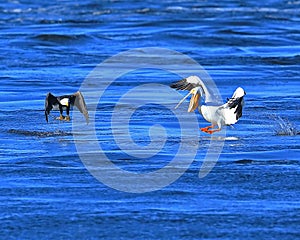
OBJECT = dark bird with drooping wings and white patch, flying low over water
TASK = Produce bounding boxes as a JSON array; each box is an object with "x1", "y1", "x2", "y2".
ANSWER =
[{"x1": 45, "y1": 91, "x2": 89, "y2": 123}]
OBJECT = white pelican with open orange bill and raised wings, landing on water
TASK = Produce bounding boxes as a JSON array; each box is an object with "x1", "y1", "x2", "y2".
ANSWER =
[{"x1": 170, "y1": 76, "x2": 246, "y2": 134}]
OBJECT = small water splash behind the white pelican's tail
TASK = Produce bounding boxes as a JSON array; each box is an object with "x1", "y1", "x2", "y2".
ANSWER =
[{"x1": 272, "y1": 115, "x2": 300, "y2": 136}]
